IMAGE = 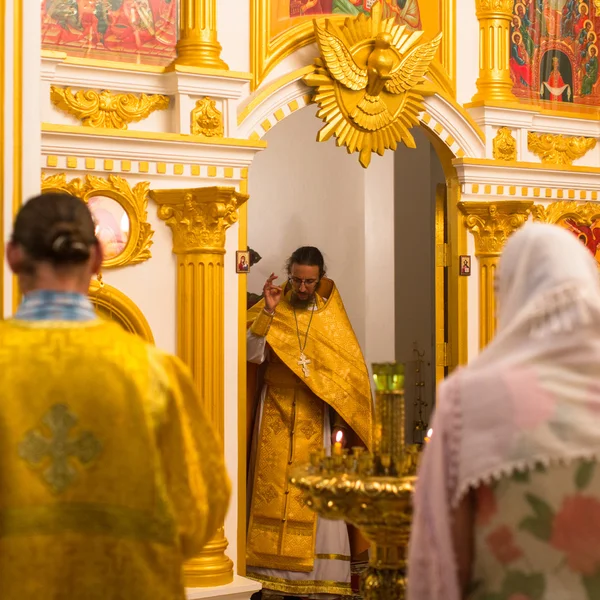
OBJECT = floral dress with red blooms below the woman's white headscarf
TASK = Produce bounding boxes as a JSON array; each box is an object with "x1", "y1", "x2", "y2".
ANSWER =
[{"x1": 467, "y1": 460, "x2": 600, "y2": 600}]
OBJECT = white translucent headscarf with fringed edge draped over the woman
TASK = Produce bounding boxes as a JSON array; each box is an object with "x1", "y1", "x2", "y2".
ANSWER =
[{"x1": 407, "y1": 223, "x2": 600, "y2": 600}]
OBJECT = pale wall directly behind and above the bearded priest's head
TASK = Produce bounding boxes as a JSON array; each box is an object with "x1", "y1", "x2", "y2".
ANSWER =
[{"x1": 248, "y1": 106, "x2": 366, "y2": 351}]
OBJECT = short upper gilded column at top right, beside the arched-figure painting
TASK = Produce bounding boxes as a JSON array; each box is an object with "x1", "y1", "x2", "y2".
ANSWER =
[{"x1": 473, "y1": 0, "x2": 515, "y2": 102}]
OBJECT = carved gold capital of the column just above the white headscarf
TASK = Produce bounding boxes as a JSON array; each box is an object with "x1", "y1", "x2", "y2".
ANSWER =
[{"x1": 458, "y1": 200, "x2": 533, "y2": 257}]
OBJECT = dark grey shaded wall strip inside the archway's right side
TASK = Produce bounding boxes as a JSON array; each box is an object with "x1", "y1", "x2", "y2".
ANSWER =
[{"x1": 394, "y1": 130, "x2": 444, "y2": 440}]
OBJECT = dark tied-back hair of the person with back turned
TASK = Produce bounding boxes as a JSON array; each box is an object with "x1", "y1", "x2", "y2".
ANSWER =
[{"x1": 11, "y1": 192, "x2": 98, "y2": 267}]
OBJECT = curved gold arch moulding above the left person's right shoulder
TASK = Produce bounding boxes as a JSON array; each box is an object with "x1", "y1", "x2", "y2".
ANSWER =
[{"x1": 88, "y1": 280, "x2": 154, "y2": 344}]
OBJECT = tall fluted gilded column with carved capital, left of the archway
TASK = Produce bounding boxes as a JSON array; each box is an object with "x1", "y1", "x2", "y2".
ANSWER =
[{"x1": 150, "y1": 187, "x2": 248, "y2": 587}]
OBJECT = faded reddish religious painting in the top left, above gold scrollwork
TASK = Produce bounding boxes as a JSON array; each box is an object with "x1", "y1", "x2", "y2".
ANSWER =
[{"x1": 42, "y1": 0, "x2": 178, "y2": 65}]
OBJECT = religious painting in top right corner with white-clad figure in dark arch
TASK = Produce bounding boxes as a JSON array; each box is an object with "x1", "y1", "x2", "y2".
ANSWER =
[{"x1": 510, "y1": 0, "x2": 600, "y2": 108}]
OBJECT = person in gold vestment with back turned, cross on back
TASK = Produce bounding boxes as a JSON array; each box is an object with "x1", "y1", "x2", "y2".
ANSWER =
[{"x1": 0, "y1": 194, "x2": 229, "y2": 600}]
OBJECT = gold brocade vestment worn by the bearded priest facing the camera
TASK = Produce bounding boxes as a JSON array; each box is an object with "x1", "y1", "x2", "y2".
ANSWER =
[{"x1": 247, "y1": 280, "x2": 372, "y2": 572}]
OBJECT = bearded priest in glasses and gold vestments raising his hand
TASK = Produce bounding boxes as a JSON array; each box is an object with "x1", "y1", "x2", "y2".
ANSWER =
[{"x1": 247, "y1": 247, "x2": 373, "y2": 597}]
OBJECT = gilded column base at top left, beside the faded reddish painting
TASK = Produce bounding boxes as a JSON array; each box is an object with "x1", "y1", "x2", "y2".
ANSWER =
[{"x1": 175, "y1": 0, "x2": 229, "y2": 70}]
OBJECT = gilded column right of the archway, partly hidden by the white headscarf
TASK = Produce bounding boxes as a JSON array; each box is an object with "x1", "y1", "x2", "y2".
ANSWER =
[{"x1": 459, "y1": 200, "x2": 533, "y2": 348}]
